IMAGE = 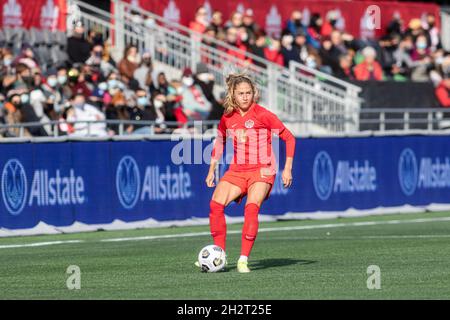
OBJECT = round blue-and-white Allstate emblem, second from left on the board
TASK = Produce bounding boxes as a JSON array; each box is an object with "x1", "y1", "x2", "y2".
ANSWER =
[{"x1": 116, "y1": 156, "x2": 140, "y2": 209}]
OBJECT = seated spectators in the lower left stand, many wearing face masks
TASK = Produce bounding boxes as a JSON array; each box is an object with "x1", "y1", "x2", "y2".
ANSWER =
[{"x1": 0, "y1": 22, "x2": 223, "y2": 137}]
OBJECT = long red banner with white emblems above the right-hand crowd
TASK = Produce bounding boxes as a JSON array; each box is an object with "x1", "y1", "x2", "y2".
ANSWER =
[{"x1": 116, "y1": 0, "x2": 440, "y2": 38}]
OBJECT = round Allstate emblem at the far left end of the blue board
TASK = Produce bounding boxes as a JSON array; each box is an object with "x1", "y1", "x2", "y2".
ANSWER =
[{"x1": 1, "y1": 159, "x2": 27, "y2": 215}]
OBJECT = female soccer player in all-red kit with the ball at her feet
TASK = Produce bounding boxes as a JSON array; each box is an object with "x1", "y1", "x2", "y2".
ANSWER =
[{"x1": 206, "y1": 74, "x2": 295, "y2": 273}]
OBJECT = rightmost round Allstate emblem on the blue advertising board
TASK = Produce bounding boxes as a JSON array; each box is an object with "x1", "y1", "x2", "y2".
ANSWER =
[{"x1": 398, "y1": 148, "x2": 419, "y2": 196}]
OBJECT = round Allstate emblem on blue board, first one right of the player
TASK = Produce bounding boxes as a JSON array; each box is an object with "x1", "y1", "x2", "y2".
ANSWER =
[{"x1": 313, "y1": 151, "x2": 334, "y2": 200}]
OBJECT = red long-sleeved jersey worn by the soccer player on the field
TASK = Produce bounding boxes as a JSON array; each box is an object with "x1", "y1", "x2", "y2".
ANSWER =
[{"x1": 212, "y1": 103, "x2": 295, "y2": 171}]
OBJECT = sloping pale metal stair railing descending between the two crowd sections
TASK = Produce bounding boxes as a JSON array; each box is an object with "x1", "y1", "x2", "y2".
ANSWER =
[{"x1": 67, "y1": 0, "x2": 361, "y2": 133}]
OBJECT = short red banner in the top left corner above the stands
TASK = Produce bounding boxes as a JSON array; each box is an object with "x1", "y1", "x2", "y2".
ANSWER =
[{"x1": 0, "y1": 0, "x2": 67, "y2": 31}]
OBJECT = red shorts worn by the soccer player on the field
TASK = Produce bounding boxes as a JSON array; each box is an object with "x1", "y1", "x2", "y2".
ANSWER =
[{"x1": 220, "y1": 168, "x2": 276, "y2": 203}]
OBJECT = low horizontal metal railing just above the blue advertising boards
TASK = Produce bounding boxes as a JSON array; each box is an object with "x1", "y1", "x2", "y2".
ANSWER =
[{"x1": 0, "y1": 109, "x2": 450, "y2": 142}]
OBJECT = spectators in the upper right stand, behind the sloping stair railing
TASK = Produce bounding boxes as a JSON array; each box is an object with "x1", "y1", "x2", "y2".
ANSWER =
[{"x1": 189, "y1": 7, "x2": 450, "y2": 81}]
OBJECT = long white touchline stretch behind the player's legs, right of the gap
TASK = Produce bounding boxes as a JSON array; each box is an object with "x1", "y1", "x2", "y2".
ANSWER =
[{"x1": 100, "y1": 217, "x2": 450, "y2": 242}]
